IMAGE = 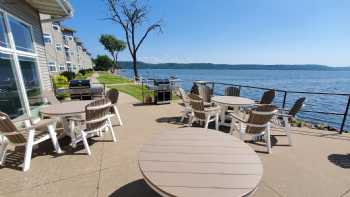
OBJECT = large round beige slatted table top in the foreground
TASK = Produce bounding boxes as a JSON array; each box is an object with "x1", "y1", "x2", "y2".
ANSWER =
[{"x1": 139, "y1": 128, "x2": 263, "y2": 197}]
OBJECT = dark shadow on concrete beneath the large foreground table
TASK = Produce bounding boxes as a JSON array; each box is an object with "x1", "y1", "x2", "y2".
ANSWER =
[{"x1": 109, "y1": 179, "x2": 160, "y2": 197}]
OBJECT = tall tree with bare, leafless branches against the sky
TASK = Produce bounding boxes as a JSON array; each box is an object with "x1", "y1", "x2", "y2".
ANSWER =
[{"x1": 106, "y1": 0, "x2": 162, "y2": 80}]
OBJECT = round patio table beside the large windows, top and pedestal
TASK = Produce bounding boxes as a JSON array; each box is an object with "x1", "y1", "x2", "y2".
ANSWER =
[{"x1": 40, "y1": 100, "x2": 92, "y2": 140}]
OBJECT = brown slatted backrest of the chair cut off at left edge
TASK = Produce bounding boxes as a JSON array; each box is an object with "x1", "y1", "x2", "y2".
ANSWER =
[{"x1": 0, "y1": 112, "x2": 26, "y2": 144}]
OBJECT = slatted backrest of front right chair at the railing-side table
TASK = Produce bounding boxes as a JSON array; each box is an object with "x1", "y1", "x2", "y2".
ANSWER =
[{"x1": 246, "y1": 105, "x2": 278, "y2": 134}]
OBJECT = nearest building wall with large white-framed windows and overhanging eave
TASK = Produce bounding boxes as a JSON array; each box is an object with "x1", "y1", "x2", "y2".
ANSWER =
[{"x1": 0, "y1": 0, "x2": 73, "y2": 118}]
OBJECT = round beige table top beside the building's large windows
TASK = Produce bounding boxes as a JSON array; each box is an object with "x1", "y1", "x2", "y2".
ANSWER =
[{"x1": 40, "y1": 100, "x2": 92, "y2": 116}]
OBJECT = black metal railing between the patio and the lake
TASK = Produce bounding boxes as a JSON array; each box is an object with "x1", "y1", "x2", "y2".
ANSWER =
[{"x1": 193, "y1": 81, "x2": 350, "y2": 133}]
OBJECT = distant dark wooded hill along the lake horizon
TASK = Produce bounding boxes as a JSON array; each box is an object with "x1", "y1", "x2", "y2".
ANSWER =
[{"x1": 119, "y1": 62, "x2": 350, "y2": 71}]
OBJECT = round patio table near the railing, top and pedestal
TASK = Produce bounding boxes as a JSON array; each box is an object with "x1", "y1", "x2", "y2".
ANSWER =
[{"x1": 211, "y1": 96, "x2": 255, "y2": 126}]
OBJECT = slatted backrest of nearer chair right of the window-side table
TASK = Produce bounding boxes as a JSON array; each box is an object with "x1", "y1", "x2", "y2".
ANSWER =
[{"x1": 85, "y1": 98, "x2": 111, "y2": 131}]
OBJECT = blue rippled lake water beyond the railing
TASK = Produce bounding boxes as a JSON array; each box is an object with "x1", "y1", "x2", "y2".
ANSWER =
[{"x1": 122, "y1": 69, "x2": 350, "y2": 130}]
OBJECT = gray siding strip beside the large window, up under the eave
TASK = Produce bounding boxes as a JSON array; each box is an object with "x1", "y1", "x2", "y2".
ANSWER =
[{"x1": 0, "y1": 0, "x2": 52, "y2": 89}]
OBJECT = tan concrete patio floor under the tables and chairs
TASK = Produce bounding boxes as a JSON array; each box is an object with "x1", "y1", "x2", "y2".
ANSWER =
[{"x1": 0, "y1": 94, "x2": 350, "y2": 197}]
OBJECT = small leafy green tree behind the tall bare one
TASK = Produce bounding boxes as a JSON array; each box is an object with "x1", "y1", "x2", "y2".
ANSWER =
[{"x1": 100, "y1": 34, "x2": 126, "y2": 73}]
